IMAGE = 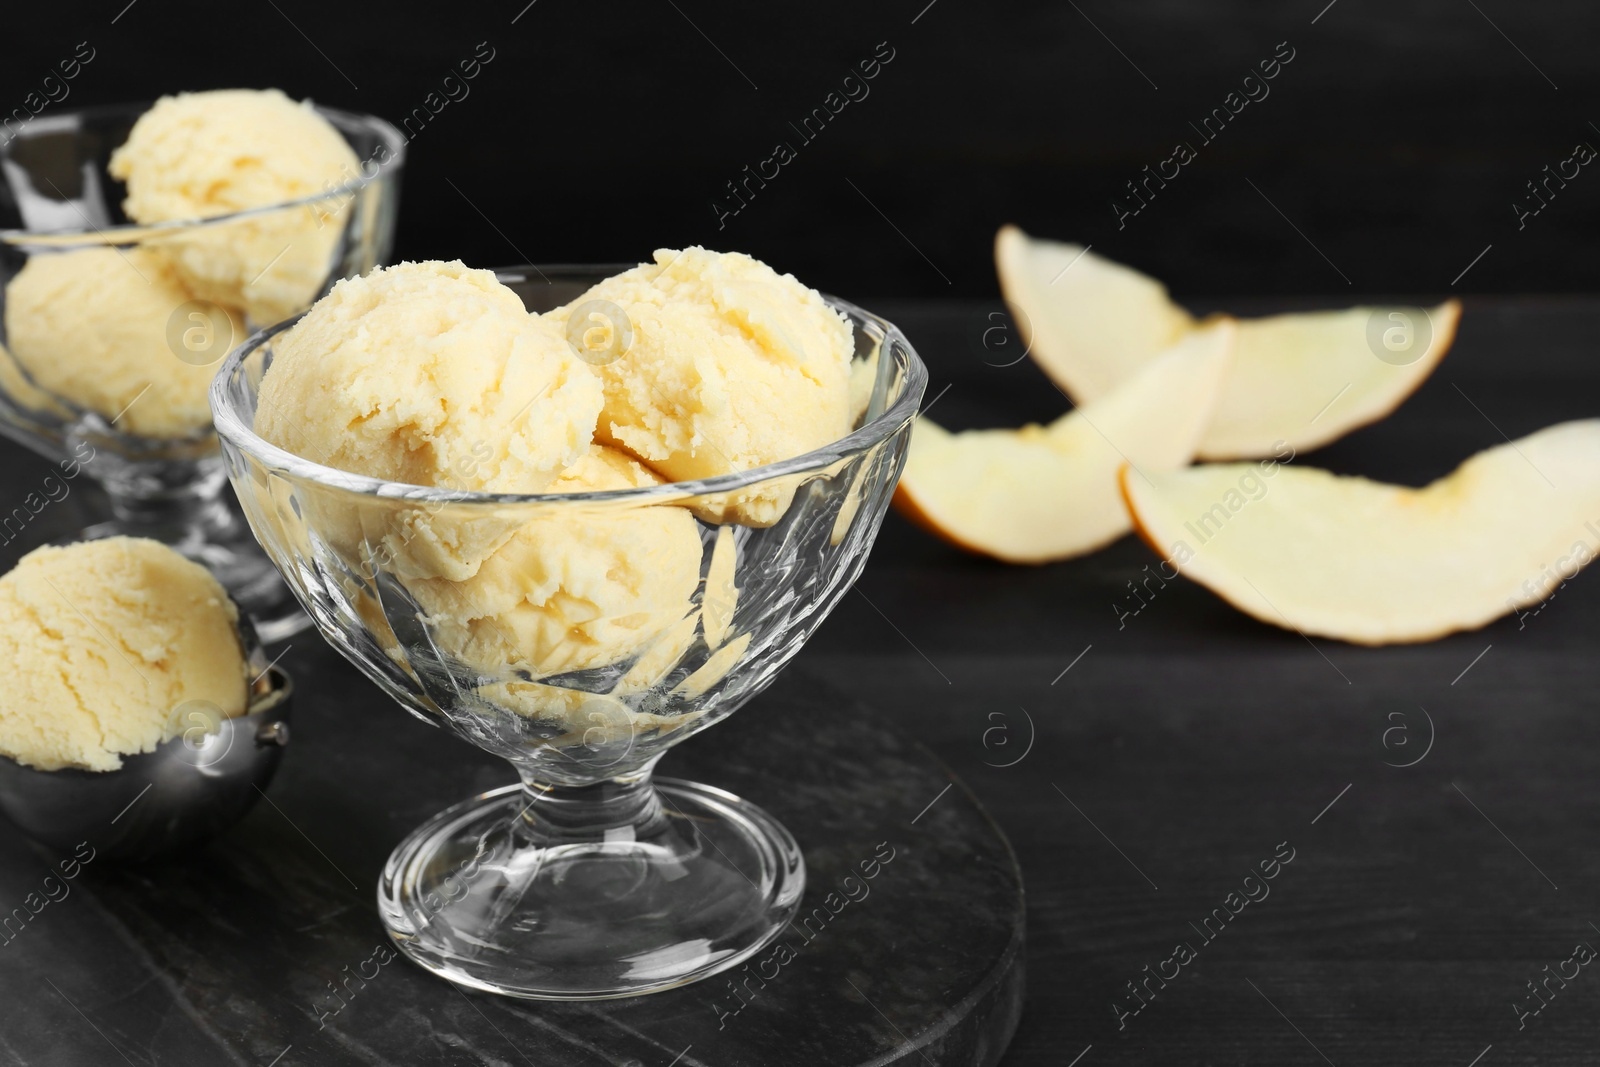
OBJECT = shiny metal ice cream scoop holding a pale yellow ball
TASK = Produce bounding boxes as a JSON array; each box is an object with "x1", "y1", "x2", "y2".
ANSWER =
[{"x1": 0, "y1": 665, "x2": 294, "y2": 859}]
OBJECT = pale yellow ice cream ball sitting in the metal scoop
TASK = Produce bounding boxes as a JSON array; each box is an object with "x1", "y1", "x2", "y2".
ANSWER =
[{"x1": 0, "y1": 537, "x2": 248, "y2": 771}]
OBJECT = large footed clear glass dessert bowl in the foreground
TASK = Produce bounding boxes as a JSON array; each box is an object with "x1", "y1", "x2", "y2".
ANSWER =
[{"x1": 211, "y1": 267, "x2": 926, "y2": 1000}]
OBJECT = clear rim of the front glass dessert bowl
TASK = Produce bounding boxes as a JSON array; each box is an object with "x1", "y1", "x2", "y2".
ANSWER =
[{"x1": 210, "y1": 275, "x2": 928, "y2": 507}]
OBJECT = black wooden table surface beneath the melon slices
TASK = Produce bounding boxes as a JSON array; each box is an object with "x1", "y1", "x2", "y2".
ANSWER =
[{"x1": 0, "y1": 298, "x2": 1600, "y2": 1067}]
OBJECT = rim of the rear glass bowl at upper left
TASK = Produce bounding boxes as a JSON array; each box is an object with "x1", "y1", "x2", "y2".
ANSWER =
[{"x1": 0, "y1": 101, "x2": 408, "y2": 248}]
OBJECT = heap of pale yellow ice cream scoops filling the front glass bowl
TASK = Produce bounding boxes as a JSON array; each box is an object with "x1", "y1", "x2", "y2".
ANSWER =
[{"x1": 256, "y1": 248, "x2": 856, "y2": 744}]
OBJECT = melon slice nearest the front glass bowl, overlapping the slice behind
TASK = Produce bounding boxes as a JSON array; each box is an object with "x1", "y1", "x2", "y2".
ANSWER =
[{"x1": 894, "y1": 320, "x2": 1235, "y2": 563}]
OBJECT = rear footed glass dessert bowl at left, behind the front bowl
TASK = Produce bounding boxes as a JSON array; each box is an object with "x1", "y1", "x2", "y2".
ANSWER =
[{"x1": 0, "y1": 104, "x2": 405, "y2": 641}]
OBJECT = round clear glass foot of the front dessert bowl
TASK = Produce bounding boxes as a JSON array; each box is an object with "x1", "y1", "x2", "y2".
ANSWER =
[{"x1": 378, "y1": 779, "x2": 805, "y2": 1000}]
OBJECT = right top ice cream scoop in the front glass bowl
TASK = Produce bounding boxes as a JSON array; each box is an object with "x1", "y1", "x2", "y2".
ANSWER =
[{"x1": 547, "y1": 248, "x2": 854, "y2": 525}]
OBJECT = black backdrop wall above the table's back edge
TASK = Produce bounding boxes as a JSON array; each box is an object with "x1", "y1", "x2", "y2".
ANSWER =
[{"x1": 0, "y1": 0, "x2": 1600, "y2": 299}]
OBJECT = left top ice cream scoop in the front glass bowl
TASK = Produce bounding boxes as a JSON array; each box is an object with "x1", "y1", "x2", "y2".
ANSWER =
[{"x1": 256, "y1": 262, "x2": 600, "y2": 579}]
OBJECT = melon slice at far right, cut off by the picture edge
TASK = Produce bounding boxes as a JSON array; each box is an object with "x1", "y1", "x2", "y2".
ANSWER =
[{"x1": 1122, "y1": 419, "x2": 1600, "y2": 645}]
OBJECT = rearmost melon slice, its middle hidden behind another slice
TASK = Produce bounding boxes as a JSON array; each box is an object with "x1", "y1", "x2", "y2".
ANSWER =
[{"x1": 995, "y1": 226, "x2": 1461, "y2": 459}]
